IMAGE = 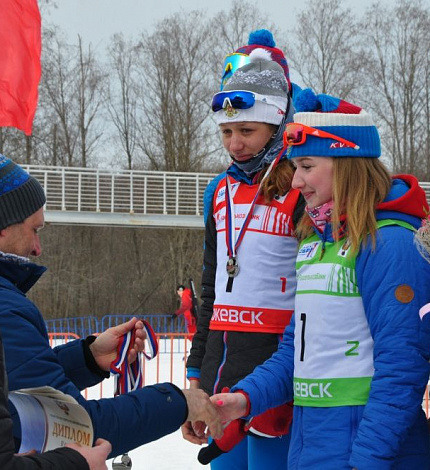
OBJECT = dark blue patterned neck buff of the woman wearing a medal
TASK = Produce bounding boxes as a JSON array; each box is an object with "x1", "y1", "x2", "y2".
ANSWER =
[{"x1": 231, "y1": 99, "x2": 294, "y2": 178}]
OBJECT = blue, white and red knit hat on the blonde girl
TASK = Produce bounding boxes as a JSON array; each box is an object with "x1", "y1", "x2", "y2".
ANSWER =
[{"x1": 288, "y1": 88, "x2": 381, "y2": 158}]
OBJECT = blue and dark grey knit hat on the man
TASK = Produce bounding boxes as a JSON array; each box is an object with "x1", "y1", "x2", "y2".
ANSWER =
[{"x1": 0, "y1": 154, "x2": 46, "y2": 230}]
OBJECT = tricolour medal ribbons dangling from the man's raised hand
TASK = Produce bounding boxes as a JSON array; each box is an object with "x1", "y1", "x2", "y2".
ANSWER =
[{"x1": 110, "y1": 320, "x2": 158, "y2": 396}]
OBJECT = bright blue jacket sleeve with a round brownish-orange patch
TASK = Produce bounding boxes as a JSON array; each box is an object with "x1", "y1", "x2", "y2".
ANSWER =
[{"x1": 349, "y1": 226, "x2": 430, "y2": 469}]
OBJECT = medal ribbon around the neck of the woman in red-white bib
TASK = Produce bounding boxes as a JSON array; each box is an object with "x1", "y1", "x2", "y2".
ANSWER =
[{"x1": 225, "y1": 147, "x2": 287, "y2": 258}]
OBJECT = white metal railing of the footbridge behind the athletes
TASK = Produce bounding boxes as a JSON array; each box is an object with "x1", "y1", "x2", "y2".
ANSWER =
[{"x1": 23, "y1": 165, "x2": 215, "y2": 216}]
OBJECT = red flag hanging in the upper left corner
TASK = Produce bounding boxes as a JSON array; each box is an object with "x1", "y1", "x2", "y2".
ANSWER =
[{"x1": 0, "y1": 0, "x2": 42, "y2": 135}]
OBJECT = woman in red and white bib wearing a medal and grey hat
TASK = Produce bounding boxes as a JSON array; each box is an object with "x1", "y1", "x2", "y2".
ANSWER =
[{"x1": 182, "y1": 34, "x2": 304, "y2": 470}]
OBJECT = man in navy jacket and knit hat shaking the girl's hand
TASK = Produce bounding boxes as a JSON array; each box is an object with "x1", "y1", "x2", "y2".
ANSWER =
[{"x1": 0, "y1": 155, "x2": 222, "y2": 457}]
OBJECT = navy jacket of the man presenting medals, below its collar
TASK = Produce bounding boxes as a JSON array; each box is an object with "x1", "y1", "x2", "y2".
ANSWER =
[{"x1": 0, "y1": 293, "x2": 188, "y2": 457}]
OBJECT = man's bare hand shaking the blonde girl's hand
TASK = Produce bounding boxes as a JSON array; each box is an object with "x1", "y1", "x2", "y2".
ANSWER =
[{"x1": 182, "y1": 389, "x2": 223, "y2": 444}]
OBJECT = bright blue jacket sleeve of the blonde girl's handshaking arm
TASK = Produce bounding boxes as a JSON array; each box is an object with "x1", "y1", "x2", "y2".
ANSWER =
[{"x1": 231, "y1": 315, "x2": 295, "y2": 416}]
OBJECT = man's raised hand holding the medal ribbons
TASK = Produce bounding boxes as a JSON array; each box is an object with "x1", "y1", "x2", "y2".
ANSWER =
[{"x1": 90, "y1": 317, "x2": 146, "y2": 372}]
